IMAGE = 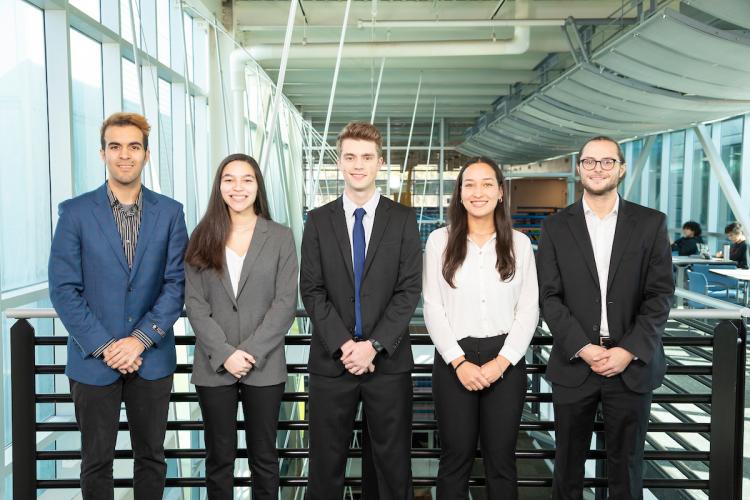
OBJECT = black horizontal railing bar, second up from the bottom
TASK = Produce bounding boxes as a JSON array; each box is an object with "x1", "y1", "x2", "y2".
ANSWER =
[{"x1": 36, "y1": 447, "x2": 710, "y2": 462}]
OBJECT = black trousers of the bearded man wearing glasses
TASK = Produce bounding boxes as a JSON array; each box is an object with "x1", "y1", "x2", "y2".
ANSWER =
[{"x1": 552, "y1": 373, "x2": 652, "y2": 500}]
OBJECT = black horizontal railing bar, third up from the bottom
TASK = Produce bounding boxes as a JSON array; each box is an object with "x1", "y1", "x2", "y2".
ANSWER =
[{"x1": 36, "y1": 420, "x2": 711, "y2": 433}]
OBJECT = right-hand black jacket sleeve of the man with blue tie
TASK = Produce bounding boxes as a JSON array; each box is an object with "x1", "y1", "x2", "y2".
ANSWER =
[{"x1": 370, "y1": 210, "x2": 422, "y2": 355}]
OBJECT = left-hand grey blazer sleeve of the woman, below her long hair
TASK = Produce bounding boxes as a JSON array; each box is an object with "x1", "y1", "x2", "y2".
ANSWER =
[{"x1": 185, "y1": 264, "x2": 236, "y2": 373}]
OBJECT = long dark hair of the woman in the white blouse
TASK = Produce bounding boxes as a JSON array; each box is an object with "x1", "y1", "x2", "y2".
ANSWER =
[{"x1": 443, "y1": 156, "x2": 516, "y2": 288}]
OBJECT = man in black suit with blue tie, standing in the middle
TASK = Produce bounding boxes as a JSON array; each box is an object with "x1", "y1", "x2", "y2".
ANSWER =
[{"x1": 300, "y1": 122, "x2": 422, "y2": 500}]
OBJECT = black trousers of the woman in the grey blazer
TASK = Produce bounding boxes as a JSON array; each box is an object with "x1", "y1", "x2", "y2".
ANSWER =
[{"x1": 195, "y1": 383, "x2": 284, "y2": 500}]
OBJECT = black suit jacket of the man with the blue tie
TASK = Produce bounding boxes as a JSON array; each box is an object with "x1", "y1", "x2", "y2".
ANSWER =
[{"x1": 300, "y1": 196, "x2": 422, "y2": 376}]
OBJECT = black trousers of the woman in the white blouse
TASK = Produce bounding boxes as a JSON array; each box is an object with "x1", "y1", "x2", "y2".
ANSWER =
[{"x1": 432, "y1": 335, "x2": 526, "y2": 500}]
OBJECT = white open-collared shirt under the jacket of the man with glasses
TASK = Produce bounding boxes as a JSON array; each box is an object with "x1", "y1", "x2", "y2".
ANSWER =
[{"x1": 582, "y1": 195, "x2": 620, "y2": 337}]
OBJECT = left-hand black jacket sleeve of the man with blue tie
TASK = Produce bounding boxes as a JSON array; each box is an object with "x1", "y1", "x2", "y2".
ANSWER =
[{"x1": 299, "y1": 212, "x2": 352, "y2": 358}]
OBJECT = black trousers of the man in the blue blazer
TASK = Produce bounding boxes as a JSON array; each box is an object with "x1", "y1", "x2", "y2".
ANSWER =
[{"x1": 70, "y1": 373, "x2": 172, "y2": 500}]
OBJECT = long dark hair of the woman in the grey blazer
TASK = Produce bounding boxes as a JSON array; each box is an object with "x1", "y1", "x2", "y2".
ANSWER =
[{"x1": 185, "y1": 153, "x2": 271, "y2": 271}]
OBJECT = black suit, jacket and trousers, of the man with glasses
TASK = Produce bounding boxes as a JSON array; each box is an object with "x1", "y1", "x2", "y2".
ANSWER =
[{"x1": 537, "y1": 200, "x2": 674, "y2": 499}]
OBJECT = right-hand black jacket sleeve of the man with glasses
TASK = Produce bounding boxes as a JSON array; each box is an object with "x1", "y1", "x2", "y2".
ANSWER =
[{"x1": 619, "y1": 214, "x2": 674, "y2": 364}]
